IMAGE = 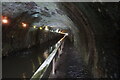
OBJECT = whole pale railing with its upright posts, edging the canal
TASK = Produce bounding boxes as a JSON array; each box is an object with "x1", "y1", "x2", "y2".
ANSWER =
[{"x1": 30, "y1": 34, "x2": 68, "y2": 80}]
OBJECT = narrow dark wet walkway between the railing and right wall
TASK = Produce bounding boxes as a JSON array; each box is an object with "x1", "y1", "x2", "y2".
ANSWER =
[{"x1": 50, "y1": 39, "x2": 90, "y2": 78}]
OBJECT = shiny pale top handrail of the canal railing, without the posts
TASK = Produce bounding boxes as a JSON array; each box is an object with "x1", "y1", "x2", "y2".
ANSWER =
[{"x1": 30, "y1": 35, "x2": 67, "y2": 80}]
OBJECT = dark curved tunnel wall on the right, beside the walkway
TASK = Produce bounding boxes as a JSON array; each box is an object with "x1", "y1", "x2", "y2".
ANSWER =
[{"x1": 62, "y1": 3, "x2": 120, "y2": 78}]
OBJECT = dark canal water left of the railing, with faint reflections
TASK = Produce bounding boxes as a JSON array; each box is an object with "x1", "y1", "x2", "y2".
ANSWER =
[{"x1": 2, "y1": 37, "x2": 61, "y2": 78}]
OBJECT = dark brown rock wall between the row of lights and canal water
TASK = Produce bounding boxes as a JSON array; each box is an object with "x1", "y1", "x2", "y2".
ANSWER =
[{"x1": 2, "y1": 26, "x2": 60, "y2": 56}]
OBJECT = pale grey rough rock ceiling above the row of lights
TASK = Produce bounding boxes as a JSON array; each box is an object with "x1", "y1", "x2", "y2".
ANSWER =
[{"x1": 2, "y1": 2, "x2": 75, "y2": 29}]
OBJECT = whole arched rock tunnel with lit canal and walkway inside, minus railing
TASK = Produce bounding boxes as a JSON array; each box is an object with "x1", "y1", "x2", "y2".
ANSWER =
[{"x1": 2, "y1": 2, "x2": 120, "y2": 79}]
